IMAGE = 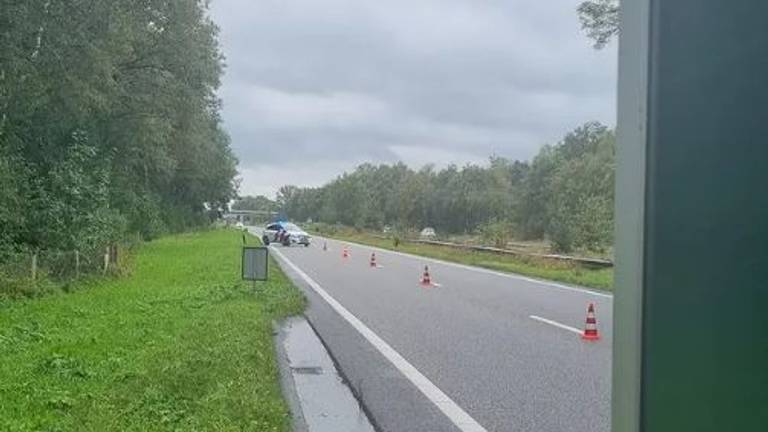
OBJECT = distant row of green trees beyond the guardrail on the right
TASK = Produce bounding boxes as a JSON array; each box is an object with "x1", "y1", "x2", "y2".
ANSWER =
[{"x1": 272, "y1": 122, "x2": 615, "y2": 252}]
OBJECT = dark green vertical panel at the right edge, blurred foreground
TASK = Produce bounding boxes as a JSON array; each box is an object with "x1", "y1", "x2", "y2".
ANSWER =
[{"x1": 640, "y1": 0, "x2": 768, "y2": 432}]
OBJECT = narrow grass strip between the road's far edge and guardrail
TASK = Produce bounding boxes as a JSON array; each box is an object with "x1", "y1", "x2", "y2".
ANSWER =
[{"x1": 322, "y1": 231, "x2": 613, "y2": 291}]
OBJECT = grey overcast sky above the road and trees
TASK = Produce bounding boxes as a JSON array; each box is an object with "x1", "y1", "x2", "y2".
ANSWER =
[{"x1": 212, "y1": 0, "x2": 616, "y2": 197}]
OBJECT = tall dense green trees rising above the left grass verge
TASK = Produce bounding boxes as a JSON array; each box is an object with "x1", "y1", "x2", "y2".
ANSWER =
[{"x1": 0, "y1": 0, "x2": 237, "y2": 258}]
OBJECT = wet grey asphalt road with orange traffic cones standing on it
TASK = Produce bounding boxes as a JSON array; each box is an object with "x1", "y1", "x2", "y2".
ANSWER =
[{"x1": 258, "y1": 233, "x2": 613, "y2": 432}]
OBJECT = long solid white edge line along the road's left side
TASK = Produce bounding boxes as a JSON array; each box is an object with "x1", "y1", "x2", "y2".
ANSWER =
[{"x1": 271, "y1": 248, "x2": 488, "y2": 432}]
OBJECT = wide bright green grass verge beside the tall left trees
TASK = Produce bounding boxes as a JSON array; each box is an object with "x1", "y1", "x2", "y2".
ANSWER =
[{"x1": 0, "y1": 230, "x2": 305, "y2": 432}]
